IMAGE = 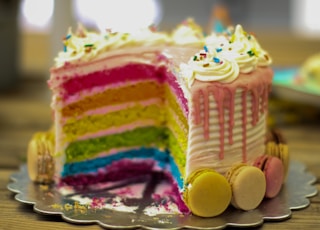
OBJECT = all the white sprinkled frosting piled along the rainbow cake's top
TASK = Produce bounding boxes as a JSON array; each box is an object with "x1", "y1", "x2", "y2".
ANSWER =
[{"x1": 55, "y1": 18, "x2": 272, "y2": 87}]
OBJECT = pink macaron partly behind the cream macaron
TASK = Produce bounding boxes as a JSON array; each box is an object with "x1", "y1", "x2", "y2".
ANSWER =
[{"x1": 253, "y1": 155, "x2": 284, "y2": 198}]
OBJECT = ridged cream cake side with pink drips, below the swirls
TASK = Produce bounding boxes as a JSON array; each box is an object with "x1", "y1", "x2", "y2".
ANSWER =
[{"x1": 187, "y1": 68, "x2": 273, "y2": 175}]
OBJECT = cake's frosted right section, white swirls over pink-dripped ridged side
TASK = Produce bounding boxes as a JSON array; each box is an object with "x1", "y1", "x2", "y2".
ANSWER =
[{"x1": 182, "y1": 25, "x2": 273, "y2": 175}]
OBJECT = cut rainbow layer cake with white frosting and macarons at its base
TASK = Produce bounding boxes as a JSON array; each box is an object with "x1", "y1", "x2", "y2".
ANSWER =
[{"x1": 29, "y1": 20, "x2": 287, "y2": 217}]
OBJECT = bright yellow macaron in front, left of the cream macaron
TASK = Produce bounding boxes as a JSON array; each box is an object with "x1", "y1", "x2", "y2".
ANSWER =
[{"x1": 184, "y1": 169, "x2": 231, "y2": 217}]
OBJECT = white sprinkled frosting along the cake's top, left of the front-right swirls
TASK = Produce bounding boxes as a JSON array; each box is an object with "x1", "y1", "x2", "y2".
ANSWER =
[{"x1": 55, "y1": 19, "x2": 204, "y2": 68}]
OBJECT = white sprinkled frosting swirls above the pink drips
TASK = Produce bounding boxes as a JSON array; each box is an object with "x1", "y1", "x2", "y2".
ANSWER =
[{"x1": 180, "y1": 25, "x2": 272, "y2": 87}]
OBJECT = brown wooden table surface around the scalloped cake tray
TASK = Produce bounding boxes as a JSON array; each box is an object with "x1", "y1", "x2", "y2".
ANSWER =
[{"x1": 0, "y1": 81, "x2": 320, "y2": 230}]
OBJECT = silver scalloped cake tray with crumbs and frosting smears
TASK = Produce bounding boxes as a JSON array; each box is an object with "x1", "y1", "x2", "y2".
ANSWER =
[{"x1": 8, "y1": 161, "x2": 318, "y2": 229}]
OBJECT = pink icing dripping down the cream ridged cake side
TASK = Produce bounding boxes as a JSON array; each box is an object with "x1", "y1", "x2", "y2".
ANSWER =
[{"x1": 192, "y1": 68, "x2": 273, "y2": 162}]
